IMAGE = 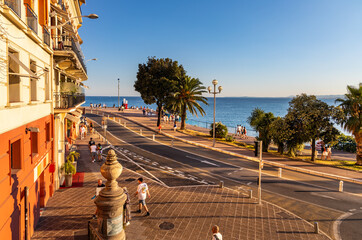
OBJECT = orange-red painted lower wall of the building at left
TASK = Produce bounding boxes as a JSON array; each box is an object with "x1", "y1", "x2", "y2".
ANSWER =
[{"x1": 0, "y1": 115, "x2": 54, "y2": 239}]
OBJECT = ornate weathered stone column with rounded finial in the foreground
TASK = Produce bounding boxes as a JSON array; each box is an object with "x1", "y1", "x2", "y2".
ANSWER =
[{"x1": 94, "y1": 150, "x2": 127, "y2": 240}]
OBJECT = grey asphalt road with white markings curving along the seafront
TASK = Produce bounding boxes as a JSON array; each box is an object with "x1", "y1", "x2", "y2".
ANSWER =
[{"x1": 88, "y1": 114, "x2": 362, "y2": 240}]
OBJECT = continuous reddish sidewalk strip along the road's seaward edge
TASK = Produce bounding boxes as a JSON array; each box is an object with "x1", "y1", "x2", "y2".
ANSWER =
[{"x1": 92, "y1": 108, "x2": 362, "y2": 180}]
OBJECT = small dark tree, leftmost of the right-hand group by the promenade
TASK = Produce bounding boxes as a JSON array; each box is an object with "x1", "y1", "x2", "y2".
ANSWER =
[{"x1": 248, "y1": 108, "x2": 275, "y2": 152}]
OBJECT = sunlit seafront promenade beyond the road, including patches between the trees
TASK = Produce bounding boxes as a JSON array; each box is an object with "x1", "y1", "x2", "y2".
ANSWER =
[{"x1": 86, "y1": 108, "x2": 362, "y2": 181}]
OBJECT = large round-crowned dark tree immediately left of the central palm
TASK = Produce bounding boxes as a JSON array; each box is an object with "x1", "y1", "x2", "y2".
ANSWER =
[{"x1": 134, "y1": 57, "x2": 186, "y2": 126}]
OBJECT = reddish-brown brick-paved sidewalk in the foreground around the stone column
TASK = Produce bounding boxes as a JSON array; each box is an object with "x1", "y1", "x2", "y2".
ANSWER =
[{"x1": 32, "y1": 136, "x2": 328, "y2": 240}]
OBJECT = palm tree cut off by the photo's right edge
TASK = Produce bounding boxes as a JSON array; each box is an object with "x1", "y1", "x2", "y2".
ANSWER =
[{"x1": 336, "y1": 84, "x2": 362, "y2": 166}]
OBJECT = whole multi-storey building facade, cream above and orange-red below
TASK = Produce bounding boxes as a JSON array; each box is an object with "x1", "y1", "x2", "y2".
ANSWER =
[{"x1": 0, "y1": 0, "x2": 87, "y2": 239}]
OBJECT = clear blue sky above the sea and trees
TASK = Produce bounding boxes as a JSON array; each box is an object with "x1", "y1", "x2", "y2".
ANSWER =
[{"x1": 79, "y1": 0, "x2": 362, "y2": 97}]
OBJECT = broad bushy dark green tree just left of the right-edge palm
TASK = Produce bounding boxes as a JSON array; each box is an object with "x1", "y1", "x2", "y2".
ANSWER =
[{"x1": 285, "y1": 94, "x2": 339, "y2": 161}]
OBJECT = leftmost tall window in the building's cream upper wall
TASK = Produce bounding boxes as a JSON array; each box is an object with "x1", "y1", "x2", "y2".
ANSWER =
[{"x1": 8, "y1": 49, "x2": 20, "y2": 103}]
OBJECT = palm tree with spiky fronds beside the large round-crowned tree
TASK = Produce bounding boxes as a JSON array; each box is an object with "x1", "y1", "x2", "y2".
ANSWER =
[{"x1": 171, "y1": 76, "x2": 208, "y2": 130}]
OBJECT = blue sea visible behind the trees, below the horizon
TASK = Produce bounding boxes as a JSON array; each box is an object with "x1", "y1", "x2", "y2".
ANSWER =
[{"x1": 84, "y1": 95, "x2": 350, "y2": 136}]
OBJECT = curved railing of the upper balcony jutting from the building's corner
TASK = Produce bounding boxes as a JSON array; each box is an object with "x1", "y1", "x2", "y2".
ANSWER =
[{"x1": 52, "y1": 36, "x2": 87, "y2": 72}]
